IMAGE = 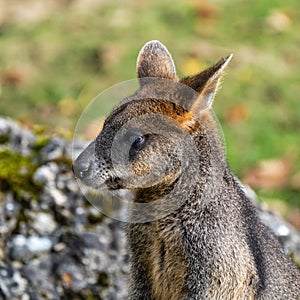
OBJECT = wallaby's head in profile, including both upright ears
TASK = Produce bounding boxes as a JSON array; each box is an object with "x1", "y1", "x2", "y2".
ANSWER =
[{"x1": 74, "y1": 41, "x2": 232, "y2": 202}]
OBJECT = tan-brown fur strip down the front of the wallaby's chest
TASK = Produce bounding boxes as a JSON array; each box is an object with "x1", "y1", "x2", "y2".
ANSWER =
[{"x1": 131, "y1": 221, "x2": 188, "y2": 300}]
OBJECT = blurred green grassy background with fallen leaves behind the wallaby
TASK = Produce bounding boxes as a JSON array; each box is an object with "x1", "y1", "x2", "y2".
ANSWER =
[{"x1": 0, "y1": 0, "x2": 300, "y2": 220}]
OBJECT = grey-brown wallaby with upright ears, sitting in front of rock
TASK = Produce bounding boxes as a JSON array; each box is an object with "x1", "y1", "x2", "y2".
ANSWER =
[{"x1": 74, "y1": 41, "x2": 300, "y2": 300}]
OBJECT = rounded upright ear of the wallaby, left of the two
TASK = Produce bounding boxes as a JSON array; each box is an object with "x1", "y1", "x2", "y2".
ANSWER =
[{"x1": 137, "y1": 41, "x2": 176, "y2": 79}]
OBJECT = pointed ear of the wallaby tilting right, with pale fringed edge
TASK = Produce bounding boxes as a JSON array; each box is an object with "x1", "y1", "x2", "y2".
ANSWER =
[{"x1": 181, "y1": 54, "x2": 233, "y2": 116}]
